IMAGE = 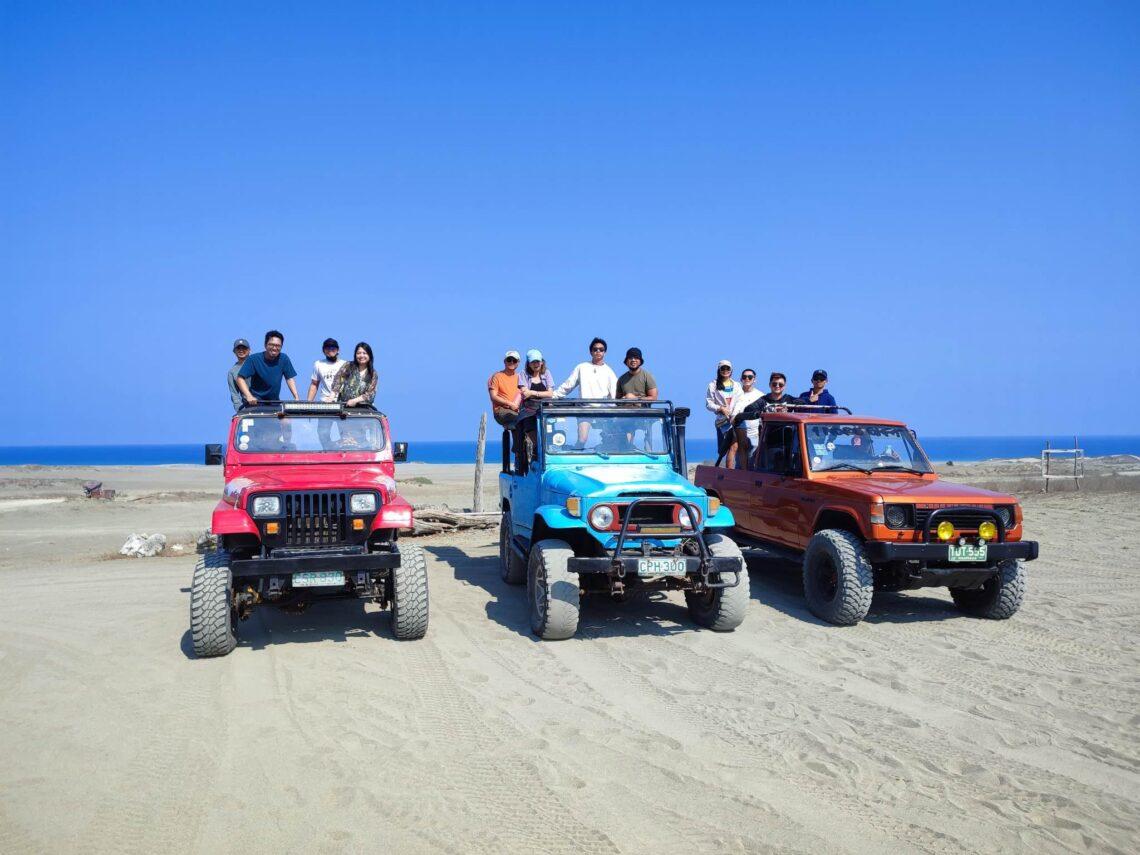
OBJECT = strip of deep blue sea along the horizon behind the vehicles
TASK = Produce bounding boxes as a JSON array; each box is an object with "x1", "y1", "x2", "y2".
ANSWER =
[{"x1": 0, "y1": 435, "x2": 1140, "y2": 466}]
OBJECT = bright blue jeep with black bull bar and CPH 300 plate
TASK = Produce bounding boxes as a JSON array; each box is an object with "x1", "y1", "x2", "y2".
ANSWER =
[{"x1": 499, "y1": 400, "x2": 749, "y2": 640}]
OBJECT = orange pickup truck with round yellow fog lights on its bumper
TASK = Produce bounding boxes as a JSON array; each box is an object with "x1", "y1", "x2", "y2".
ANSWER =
[{"x1": 694, "y1": 408, "x2": 1037, "y2": 626}]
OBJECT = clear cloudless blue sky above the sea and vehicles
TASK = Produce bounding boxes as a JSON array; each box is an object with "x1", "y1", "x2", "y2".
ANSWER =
[{"x1": 0, "y1": 0, "x2": 1140, "y2": 445}]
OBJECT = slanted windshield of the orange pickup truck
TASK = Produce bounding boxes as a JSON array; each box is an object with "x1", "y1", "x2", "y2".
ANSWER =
[{"x1": 804, "y1": 423, "x2": 934, "y2": 474}]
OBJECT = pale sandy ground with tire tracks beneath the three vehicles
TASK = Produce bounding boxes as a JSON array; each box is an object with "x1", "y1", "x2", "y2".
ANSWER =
[{"x1": 0, "y1": 461, "x2": 1140, "y2": 853}]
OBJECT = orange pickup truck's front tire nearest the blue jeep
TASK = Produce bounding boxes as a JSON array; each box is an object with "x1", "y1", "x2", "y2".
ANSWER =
[{"x1": 804, "y1": 529, "x2": 874, "y2": 626}]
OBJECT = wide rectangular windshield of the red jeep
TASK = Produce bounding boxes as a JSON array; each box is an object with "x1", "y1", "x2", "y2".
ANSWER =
[{"x1": 234, "y1": 414, "x2": 388, "y2": 454}]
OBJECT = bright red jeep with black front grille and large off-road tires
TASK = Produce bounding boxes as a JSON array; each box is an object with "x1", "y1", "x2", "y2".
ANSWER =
[{"x1": 190, "y1": 401, "x2": 428, "y2": 657}]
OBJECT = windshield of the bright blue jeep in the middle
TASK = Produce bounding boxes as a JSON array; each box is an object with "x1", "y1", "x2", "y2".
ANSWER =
[{"x1": 542, "y1": 406, "x2": 673, "y2": 463}]
